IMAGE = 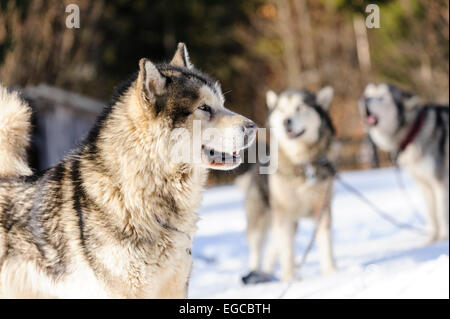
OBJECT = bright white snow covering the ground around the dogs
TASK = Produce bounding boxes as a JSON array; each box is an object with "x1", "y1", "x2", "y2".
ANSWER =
[{"x1": 189, "y1": 169, "x2": 449, "y2": 298}]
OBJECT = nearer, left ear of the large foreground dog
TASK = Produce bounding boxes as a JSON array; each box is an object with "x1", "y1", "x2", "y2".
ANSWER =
[{"x1": 137, "y1": 58, "x2": 166, "y2": 102}]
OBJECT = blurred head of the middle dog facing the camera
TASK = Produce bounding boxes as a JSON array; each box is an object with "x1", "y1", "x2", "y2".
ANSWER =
[{"x1": 266, "y1": 87, "x2": 334, "y2": 157}]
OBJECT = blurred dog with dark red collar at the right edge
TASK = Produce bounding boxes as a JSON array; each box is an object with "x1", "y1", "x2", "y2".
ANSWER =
[{"x1": 359, "y1": 84, "x2": 449, "y2": 242}]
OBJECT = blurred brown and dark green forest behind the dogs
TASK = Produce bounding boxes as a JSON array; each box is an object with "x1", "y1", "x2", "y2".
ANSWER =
[{"x1": 0, "y1": 0, "x2": 449, "y2": 178}]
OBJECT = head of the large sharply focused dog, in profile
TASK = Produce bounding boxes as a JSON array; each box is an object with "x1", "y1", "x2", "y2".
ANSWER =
[{"x1": 130, "y1": 43, "x2": 256, "y2": 170}]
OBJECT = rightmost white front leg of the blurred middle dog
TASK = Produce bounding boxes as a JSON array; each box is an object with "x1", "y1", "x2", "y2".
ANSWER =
[{"x1": 316, "y1": 209, "x2": 336, "y2": 275}]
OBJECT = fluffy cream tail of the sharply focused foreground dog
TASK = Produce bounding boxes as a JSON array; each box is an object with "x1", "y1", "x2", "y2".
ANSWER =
[{"x1": 0, "y1": 84, "x2": 32, "y2": 178}]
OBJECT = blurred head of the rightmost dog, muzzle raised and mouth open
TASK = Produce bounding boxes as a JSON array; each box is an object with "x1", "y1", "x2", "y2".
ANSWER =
[{"x1": 358, "y1": 83, "x2": 419, "y2": 151}]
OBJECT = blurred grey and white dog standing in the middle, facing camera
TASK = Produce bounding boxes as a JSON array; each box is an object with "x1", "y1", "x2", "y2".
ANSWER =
[{"x1": 242, "y1": 87, "x2": 335, "y2": 282}]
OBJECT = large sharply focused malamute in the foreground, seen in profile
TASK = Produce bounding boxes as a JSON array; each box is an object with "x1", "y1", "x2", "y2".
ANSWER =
[{"x1": 0, "y1": 44, "x2": 255, "y2": 298}]
